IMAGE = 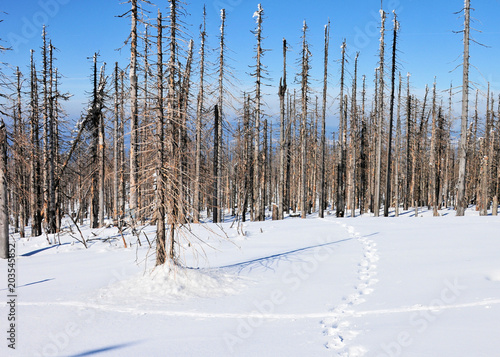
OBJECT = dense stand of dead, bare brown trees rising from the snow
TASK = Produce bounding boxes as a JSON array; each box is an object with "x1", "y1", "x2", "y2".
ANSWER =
[{"x1": 0, "y1": 0, "x2": 500, "y2": 265}]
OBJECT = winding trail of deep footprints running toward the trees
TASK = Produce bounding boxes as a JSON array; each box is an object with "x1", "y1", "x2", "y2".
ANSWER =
[{"x1": 322, "y1": 221, "x2": 379, "y2": 357}]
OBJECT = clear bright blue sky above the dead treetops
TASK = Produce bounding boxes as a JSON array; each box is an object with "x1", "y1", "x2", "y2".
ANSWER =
[{"x1": 0, "y1": 0, "x2": 500, "y2": 124}]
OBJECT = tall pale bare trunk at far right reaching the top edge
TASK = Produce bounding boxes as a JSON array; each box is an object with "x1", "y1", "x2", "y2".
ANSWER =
[{"x1": 456, "y1": 0, "x2": 470, "y2": 216}]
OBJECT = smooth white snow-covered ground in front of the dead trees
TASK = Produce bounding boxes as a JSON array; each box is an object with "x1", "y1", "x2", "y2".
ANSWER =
[{"x1": 0, "y1": 210, "x2": 500, "y2": 357}]
